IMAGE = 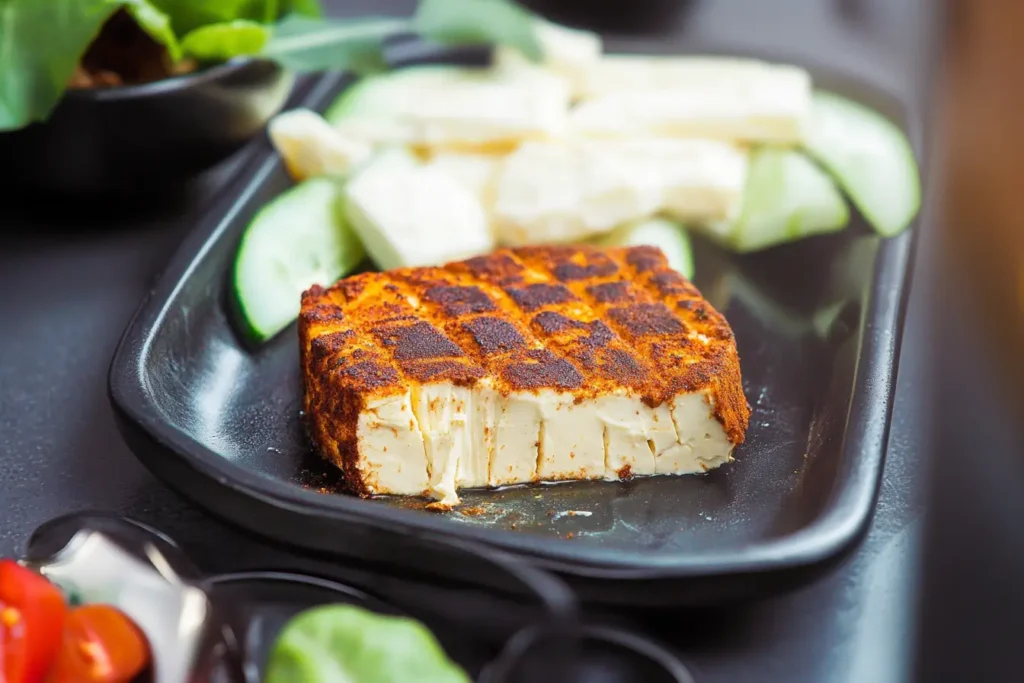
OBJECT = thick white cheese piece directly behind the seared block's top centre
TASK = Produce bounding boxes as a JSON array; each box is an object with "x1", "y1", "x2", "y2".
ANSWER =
[{"x1": 493, "y1": 138, "x2": 746, "y2": 246}]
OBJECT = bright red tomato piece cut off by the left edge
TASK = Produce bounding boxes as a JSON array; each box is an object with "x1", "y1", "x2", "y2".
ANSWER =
[{"x1": 0, "y1": 560, "x2": 68, "y2": 683}]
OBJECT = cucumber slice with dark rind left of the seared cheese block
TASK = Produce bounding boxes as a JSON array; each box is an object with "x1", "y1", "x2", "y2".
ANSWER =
[{"x1": 232, "y1": 177, "x2": 366, "y2": 341}]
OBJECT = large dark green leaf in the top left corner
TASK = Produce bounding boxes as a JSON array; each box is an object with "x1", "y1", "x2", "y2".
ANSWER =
[{"x1": 0, "y1": 0, "x2": 121, "y2": 131}]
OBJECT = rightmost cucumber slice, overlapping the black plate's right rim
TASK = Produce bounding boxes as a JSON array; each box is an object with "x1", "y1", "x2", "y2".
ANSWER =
[{"x1": 806, "y1": 91, "x2": 921, "y2": 237}]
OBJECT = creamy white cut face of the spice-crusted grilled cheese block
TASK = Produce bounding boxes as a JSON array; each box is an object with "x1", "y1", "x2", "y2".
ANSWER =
[{"x1": 357, "y1": 383, "x2": 733, "y2": 505}]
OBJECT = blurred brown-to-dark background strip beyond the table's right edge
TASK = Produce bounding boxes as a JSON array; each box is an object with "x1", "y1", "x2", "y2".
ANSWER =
[{"x1": 916, "y1": 0, "x2": 1024, "y2": 681}]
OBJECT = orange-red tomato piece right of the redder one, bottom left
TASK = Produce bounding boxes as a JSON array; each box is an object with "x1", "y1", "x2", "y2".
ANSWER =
[{"x1": 47, "y1": 605, "x2": 150, "y2": 683}]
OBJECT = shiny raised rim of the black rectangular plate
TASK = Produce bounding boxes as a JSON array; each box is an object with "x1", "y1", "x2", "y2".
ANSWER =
[{"x1": 108, "y1": 57, "x2": 927, "y2": 580}]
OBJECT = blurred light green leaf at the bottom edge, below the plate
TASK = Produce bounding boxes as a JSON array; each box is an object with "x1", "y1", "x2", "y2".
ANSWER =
[{"x1": 264, "y1": 605, "x2": 470, "y2": 683}]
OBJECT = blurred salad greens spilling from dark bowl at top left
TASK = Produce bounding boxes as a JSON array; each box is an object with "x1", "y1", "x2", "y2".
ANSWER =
[{"x1": 0, "y1": 0, "x2": 540, "y2": 131}]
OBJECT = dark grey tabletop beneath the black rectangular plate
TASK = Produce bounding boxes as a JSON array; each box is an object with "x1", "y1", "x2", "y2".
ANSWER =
[{"x1": 0, "y1": 0, "x2": 934, "y2": 683}]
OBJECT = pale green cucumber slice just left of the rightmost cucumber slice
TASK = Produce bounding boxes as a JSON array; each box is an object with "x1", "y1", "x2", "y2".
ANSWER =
[{"x1": 709, "y1": 147, "x2": 850, "y2": 253}]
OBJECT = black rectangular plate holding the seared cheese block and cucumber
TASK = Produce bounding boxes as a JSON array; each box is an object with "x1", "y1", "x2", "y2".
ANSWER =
[{"x1": 110, "y1": 45, "x2": 920, "y2": 606}]
